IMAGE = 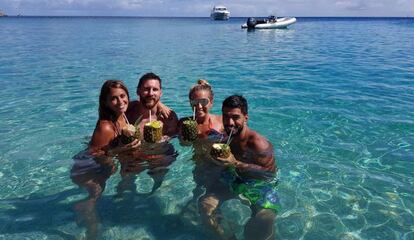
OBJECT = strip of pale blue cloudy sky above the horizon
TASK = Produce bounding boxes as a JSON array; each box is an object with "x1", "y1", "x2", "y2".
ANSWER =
[{"x1": 0, "y1": 0, "x2": 414, "y2": 17}]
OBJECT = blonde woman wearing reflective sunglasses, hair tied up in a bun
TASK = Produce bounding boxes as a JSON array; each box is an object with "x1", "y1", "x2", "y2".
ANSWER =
[{"x1": 178, "y1": 79, "x2": 228, "y2": 236}]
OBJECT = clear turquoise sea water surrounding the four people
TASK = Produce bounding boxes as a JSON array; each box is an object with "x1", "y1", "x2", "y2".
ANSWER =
[{"x1": 0, "y1": 18, "x2": 414, "y2": 239}]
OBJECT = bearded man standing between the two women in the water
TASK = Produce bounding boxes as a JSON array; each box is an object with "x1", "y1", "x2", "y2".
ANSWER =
[{"x1": 117, "y1": 72, "x2": 178, "y2": 197}]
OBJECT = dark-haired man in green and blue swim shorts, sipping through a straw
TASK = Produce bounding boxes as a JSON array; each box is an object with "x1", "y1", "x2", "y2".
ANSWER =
[{"x1": 199, "y1": 95, "x2": 280, "y2": 240}]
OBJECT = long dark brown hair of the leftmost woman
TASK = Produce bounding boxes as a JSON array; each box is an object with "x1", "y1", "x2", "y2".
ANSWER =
[{"x1": 99, "y1": 80, "x2": 129, "y2": 121}]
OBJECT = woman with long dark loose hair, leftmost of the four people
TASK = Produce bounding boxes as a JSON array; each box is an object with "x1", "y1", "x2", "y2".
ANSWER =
[{"x1": 70, "y1": 80, "x2": 139, "y2": 239}]
